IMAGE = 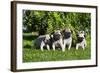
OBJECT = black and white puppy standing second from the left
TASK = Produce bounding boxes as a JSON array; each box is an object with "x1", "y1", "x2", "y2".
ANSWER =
[{"x1": 51, "y1": 30, "x2": 65, "y2": 51}]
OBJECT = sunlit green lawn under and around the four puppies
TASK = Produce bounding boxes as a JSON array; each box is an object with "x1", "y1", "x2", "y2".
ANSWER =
[{"x1": 23, "y1": 32, "x2": 91, "y2": 62}]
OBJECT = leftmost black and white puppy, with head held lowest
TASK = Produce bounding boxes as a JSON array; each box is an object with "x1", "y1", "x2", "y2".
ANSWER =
[{"x1": 35, "y1": 34, "x2": 51, "y2": 51}]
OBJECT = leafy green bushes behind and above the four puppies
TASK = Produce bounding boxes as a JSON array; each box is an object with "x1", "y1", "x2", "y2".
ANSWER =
[{"x1": 23, "y1": 10, "x2": 91, "y2": 35}]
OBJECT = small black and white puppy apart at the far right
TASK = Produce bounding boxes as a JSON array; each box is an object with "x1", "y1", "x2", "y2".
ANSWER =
[{"x1": 76, "y1": 31, "x2": 87, "y2": 50}]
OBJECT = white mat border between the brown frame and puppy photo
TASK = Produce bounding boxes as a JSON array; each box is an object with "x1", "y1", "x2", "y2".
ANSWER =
[{"x1": 17, "y1": 4, "x2": 96, "y2": 69}]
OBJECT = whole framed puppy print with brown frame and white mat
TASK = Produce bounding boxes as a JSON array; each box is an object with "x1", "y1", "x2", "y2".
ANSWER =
[{"x1": 11, "y1": 1, "x2": 98, "y2": 72}]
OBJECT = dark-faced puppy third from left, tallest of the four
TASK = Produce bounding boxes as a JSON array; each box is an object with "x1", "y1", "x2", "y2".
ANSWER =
[{"x1": 62, "y1": 29, "x2": 72, "y2": 50}]
